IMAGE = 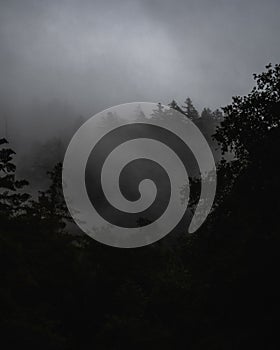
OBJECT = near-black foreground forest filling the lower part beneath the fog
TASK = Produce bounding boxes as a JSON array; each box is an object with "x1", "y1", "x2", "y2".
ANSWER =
[{"x1": 0, "y1": 64, "x2": 280, "y2": 350}]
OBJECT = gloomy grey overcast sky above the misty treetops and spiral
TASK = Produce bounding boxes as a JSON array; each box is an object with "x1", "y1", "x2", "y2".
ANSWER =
[{"x1": 0, "y1": 0, "x2": 280, "y2": 142}]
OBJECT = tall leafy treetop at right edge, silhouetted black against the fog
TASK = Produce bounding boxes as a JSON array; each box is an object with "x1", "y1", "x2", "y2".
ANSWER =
[{"x1": 214, "y1": 64, "x2": 280, "y2": 164}]
